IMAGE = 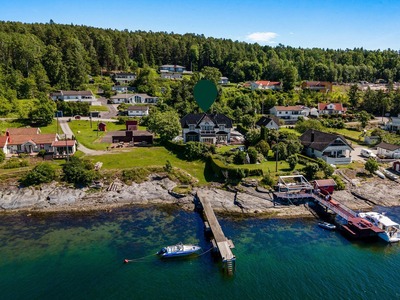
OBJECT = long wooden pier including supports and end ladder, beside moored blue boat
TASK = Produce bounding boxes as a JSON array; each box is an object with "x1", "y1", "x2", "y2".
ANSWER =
[{"x1": 197, "y1": 192, "x2": 236, "y2": 275}]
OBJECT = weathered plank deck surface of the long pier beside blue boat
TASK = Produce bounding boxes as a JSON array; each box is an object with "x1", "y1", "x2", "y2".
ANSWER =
[{"x1": 197, "y1": 192, "x2": 236, "y2": 262}]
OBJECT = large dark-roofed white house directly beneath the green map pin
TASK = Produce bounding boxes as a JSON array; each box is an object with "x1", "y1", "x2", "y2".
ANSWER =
[{"x1": 180, "y1": 113, "x2": 232, "y2": 144}]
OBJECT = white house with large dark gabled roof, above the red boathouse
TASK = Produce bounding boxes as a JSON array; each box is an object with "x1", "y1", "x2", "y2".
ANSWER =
[{"x1": 299, "y1": 129, "x2": 354, "y2": 165}]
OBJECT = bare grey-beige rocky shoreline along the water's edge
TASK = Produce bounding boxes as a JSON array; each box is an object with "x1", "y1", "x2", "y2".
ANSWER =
[{"x1": 0, "y1": 175, "x2": 400, "y2": 218}]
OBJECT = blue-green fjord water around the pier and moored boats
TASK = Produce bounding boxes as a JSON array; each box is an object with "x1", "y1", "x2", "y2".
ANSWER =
[{"x1": 0, "y1": 207, "x2": 400, "y2": 300}]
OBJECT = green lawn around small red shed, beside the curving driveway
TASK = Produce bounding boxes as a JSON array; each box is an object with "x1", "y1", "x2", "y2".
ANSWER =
[{"x1": 68, "y1": 120, "x2": 146, "y2": 150}]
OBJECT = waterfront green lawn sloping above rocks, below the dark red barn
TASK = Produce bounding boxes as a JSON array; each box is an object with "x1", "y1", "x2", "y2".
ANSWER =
[{"x1": 86, "y1": 147, "x2": 215, "y2": 184}]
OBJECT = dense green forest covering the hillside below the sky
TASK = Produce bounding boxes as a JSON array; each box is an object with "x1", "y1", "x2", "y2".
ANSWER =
[{"x1": 0, "y1": 21, "x2": 400, "y2": 99}]
